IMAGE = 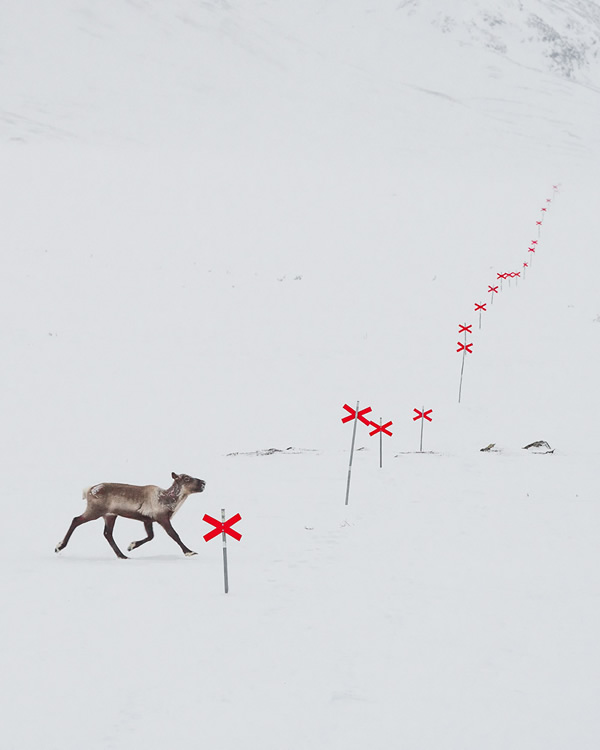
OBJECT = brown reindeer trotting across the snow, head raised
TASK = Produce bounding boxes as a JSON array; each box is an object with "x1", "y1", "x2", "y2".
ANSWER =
[{"x1": 54, "y1": 472, "x2": 206, "y2": 560}]
